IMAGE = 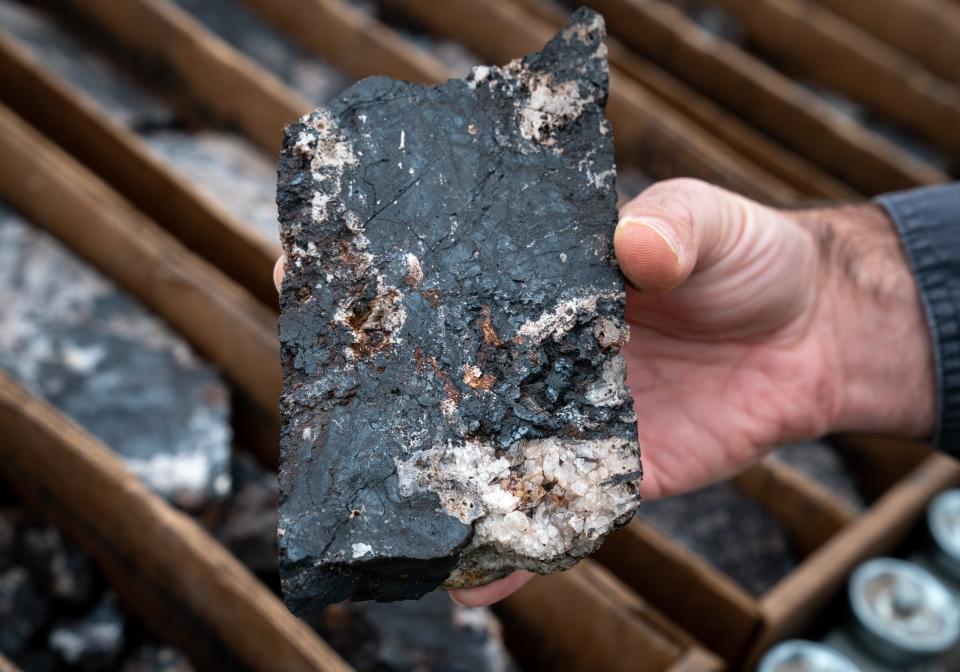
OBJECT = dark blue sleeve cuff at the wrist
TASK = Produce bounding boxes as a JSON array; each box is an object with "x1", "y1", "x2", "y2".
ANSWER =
[{"x1": 877, "y1": 183, "x2": 960, "y2": 455}]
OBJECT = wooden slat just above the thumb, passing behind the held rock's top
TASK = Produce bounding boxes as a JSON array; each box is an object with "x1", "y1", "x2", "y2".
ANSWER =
[{"x1": 390, "y1": 0, "x2": 799, "y2": 204}]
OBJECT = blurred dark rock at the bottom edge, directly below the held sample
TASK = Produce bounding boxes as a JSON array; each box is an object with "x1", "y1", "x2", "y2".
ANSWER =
[{"x1": 308, "y1": 593, "x2": 517, "y2": 672}]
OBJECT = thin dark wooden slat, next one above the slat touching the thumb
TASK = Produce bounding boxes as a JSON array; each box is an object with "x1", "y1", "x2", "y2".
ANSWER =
[{"x1": 514, "y1": 0, "x2": 857, "y2": 199}]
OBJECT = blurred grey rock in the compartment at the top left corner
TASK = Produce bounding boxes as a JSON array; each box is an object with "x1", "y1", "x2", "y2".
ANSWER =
[{"x1": 0, "y1": 0, "x2": 176, "y2": 128}]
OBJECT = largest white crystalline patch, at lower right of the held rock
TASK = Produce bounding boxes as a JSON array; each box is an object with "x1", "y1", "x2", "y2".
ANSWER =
[{"x1": 395, "y1": 437, "x2": 640, "y2": 560}]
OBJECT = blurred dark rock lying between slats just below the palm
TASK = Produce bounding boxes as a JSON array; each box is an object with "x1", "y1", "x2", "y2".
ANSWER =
[{"x1": 637, "y1": 483, "x2": 797, "y2": 596}]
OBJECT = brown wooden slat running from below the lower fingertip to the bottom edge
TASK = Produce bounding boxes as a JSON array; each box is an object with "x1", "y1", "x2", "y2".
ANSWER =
[{"x1": 497, "y1": 560, "x2": 716, "y2": 672}]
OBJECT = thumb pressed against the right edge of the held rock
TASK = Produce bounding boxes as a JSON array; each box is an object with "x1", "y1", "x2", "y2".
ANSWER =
[{"x1": 613, "y1": 178, "x2": 747, "y2": 292}]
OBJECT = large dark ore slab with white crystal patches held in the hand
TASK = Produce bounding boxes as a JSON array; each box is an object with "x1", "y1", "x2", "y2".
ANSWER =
[{"x1": 278, "y1": 10, "x2": 641, "y2": 613}]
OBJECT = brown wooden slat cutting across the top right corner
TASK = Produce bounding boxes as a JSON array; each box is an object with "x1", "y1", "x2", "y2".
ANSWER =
[{"x1": 817, "y1": 0, "x2": 960, "y2": 88}]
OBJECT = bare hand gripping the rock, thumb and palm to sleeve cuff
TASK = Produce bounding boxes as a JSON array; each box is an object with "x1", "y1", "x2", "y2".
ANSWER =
[{"x1": 281, "y1": 178, "x2": 935, "y2": 606}]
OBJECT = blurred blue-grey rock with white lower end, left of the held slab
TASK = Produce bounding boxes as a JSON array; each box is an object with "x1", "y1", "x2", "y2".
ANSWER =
[{"x1": 0, "y1": 204, "x2": 231, "y2": 506}]
